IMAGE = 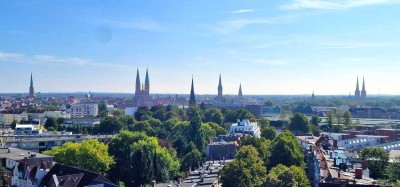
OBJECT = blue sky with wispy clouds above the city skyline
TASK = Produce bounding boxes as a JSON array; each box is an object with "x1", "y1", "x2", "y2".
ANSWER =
[{"x1": 0, "y1": 0, "x2": 400, "y2": 95}]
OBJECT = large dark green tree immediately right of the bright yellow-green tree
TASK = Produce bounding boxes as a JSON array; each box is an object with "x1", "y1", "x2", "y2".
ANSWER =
[{"x1": 109, "y1": 131, "x2": 180, "y2": 187}]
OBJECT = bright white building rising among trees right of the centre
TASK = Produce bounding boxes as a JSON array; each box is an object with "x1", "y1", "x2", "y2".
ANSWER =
[{"x1": 229, "y1": 119, "x2": 261, "y2": 137}]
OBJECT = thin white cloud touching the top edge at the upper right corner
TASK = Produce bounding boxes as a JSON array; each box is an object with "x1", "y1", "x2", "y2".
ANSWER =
[{"x1": 281, "y1": 0, "x2": 400, "y2": 10}]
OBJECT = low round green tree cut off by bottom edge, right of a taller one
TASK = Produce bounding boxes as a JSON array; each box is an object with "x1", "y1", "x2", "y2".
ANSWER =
[{"x1": 264, "y1": 164, "x2": 310, "y2": 187}]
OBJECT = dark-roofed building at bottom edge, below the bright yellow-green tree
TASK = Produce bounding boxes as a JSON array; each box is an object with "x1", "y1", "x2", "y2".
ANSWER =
[{"x1": 39, "y1": 163, "x2": 117, "y2": 187}]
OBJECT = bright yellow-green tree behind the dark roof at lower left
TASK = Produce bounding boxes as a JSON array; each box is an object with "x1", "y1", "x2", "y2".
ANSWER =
[{"x1": 43, "y1": 139, "x2": 114, "y2": 174}]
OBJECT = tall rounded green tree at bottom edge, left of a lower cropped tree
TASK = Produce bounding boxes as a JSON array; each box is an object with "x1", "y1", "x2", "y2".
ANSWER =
[{"x1": 221, "y1": 146, "x2": 267, "y2": 187}]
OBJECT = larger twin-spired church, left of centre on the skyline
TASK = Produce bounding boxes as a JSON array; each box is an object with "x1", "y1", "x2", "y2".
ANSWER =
[{"x1": 133, "y1": 69, "x2": 153, "y2": 106}]
